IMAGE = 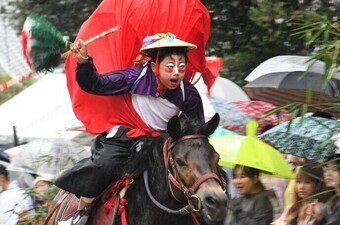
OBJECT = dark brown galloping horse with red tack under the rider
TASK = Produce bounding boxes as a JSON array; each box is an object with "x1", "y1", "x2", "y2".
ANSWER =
[{"x1": 46, "y1": 114, "x2": 228, "y2": 225}]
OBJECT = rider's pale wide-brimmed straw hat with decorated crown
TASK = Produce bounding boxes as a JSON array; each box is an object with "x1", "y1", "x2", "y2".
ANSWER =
[{"x1": 140, "y1": 33, "x2": 197, "y2": 53}]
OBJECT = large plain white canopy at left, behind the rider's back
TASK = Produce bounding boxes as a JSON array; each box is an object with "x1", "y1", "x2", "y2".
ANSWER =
[{"x1": 0, "y1": 71, "x2": 79, "y2": 140}]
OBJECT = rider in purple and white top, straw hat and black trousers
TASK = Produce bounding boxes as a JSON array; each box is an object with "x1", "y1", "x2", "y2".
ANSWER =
[{"x1": 55, "y1": 33, "x2": 204, "y2": 224}]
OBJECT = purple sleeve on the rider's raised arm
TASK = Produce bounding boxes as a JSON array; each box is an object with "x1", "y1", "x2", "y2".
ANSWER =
[{"x1": 76, "y1": 57, "x2": 142, "y2": 95}]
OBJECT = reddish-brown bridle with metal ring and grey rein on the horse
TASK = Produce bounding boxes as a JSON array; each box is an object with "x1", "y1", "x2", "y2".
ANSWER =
[{"x1": 143, "y1": 134, "x2": 227, "y2": 215}]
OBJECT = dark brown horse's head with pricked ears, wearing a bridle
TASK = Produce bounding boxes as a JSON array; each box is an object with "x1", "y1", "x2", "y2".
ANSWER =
[{"x1": 163, "y1": 114, "x2": 227, "y2": 224}]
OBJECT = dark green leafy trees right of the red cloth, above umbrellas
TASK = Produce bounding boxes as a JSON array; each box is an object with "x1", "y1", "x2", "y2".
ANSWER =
[{"x1": 203, "y1": 0, "x2": 340, "y2": 86}]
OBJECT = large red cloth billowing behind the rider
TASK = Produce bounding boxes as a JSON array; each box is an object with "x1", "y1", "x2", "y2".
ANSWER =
[{"x1": 65, "y1": 0, "x2": 210, "y2": 134}]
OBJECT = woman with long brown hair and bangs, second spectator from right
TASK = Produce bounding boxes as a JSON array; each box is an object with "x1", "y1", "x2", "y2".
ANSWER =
[{"x1": 272, "y1": 164, "x2": 325, "y2": 225}]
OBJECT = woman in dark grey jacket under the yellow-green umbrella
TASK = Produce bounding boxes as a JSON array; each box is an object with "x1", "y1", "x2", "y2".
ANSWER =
[{"x1": 225, "y1": 165, "x2": 273, "y2": 225}]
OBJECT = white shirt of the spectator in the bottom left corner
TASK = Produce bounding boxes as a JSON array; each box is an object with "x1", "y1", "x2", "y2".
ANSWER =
[{"x1": 0, "y1": 181, "x2": 33, "y2": 225}]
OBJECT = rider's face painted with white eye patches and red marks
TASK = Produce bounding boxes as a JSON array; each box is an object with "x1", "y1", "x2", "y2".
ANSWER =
[{"x1": 153, "y1": 54, "x2": 186, "y2": 89}]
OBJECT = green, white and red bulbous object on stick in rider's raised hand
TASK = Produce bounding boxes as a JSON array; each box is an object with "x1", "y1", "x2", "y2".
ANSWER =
[{"x1": 21, "y1": 14, "x2": 120, "y2": 72}]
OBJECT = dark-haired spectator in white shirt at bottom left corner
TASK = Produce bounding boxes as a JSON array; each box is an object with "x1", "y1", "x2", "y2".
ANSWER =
[{"x1": 0, "y1": 164, "x2": 33, "y2": 225}]
